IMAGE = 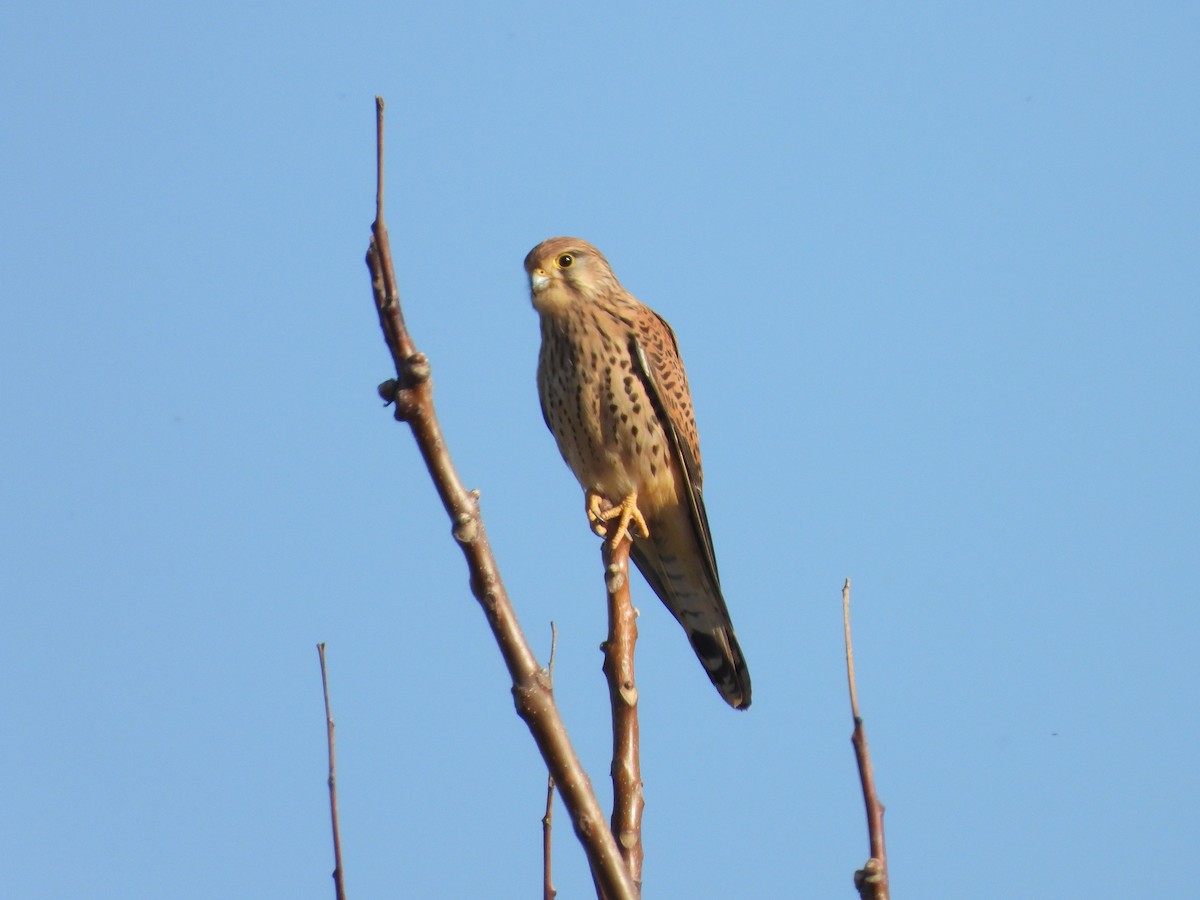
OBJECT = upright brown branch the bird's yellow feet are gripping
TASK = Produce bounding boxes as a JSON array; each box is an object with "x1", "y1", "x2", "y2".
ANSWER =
[{"x1": 604, "y1": 538, "x2": 646, "y2": 890}]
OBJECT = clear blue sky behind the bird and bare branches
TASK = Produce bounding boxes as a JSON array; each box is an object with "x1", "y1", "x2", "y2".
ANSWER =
[{"x1": 0, "y1": 1, "x2": 1200, "y2": 900}]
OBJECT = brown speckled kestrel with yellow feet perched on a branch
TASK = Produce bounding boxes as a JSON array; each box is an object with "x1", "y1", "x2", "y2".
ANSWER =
[{"x1": 524, "y1": 238, "x2": 750, "y2": 709}]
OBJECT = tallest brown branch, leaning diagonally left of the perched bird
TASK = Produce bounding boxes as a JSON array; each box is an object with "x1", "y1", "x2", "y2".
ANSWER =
[{"x1": 367, "y1": 97, "x2": 637, "y2": 900}]
